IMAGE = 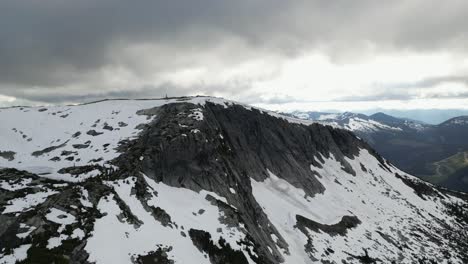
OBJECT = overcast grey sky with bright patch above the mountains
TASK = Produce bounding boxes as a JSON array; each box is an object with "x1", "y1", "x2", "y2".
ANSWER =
[{"x1": 0, "y1": 0, "x2": 468, "y2": 110}]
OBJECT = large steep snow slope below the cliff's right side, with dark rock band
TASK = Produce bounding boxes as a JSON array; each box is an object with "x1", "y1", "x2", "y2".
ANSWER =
[{"x1": 252, "y1": 150, "x2": 463, "y2": 263}]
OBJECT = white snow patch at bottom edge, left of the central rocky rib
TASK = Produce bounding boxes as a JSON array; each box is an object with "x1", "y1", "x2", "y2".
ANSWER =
[{"x1": 85, "y1": 187, "x2": 209, "y2": 264}]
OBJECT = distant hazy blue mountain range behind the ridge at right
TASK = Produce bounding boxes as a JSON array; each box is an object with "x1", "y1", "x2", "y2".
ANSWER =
[{"x1": 291, "y1": 111, "x2": 468, "y2": 191}]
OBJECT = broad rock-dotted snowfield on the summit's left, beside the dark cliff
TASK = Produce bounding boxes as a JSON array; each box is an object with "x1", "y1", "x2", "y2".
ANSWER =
[{"x1": 0, "y1": 97, "x2": 230, "y2": 181}]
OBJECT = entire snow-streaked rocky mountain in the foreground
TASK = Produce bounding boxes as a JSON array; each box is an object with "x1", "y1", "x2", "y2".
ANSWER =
[{"x1": 0, "y1": 97, "x2": 468, "y2": 264}]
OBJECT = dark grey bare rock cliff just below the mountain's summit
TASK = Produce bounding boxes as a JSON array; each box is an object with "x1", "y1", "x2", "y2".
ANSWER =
[{"x1": 117, "y1": 103, "x2": 374, "y2": 196}]
